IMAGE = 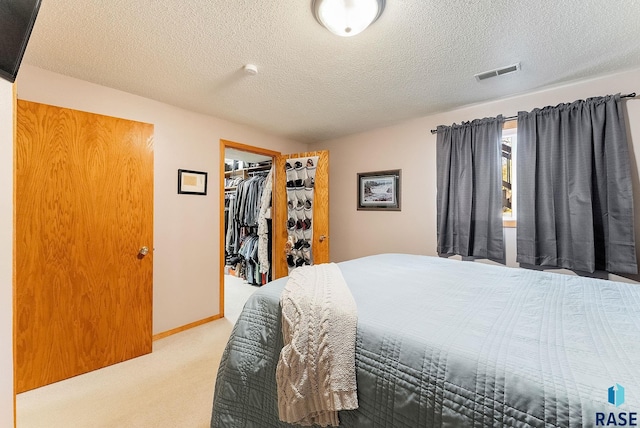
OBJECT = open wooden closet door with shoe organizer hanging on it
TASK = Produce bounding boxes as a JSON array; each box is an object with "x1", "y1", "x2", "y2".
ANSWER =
[{"x1": 273, "y1": 150, "x2": 329, "y2": 279}]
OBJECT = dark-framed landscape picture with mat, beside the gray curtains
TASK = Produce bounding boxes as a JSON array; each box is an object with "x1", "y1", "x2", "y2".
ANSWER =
[{"x1": 357, "y1": 169, "x2": 402, "y2": 211}]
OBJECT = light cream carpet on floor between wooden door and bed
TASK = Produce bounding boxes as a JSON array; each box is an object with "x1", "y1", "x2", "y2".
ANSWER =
[{"x1": 17, "y1": 277, "x2": 257, "y2": 428}]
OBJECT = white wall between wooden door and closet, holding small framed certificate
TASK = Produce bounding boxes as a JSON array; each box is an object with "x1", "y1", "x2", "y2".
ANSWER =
[{"x1": 17, "y1": 64, "x2": 307, "y2": 333}]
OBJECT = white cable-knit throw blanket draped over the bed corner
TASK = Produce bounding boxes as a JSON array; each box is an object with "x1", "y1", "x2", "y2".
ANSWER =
[{"x1": 276, "y1": 263, "x2": 358, "y2": 426}]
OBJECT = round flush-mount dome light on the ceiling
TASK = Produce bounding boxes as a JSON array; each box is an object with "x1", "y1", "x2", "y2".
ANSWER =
[{"x1": 311, "y1": 0, "x2": 385, "y2": 37}]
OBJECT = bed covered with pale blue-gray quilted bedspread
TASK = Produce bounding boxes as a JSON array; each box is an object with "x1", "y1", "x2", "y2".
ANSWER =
[{"x1": 211, "y1": 254, "x2": 640, "y2": 428}]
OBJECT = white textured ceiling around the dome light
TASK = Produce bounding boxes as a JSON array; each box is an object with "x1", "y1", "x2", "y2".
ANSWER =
[{"x1": 24, "y1": 0, "x2": 640, "y2": 142}]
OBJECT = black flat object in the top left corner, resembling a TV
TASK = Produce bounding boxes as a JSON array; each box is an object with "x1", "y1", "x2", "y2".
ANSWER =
[{"x1": 0, "y1": 0, "x2": 41, "y2": 83}]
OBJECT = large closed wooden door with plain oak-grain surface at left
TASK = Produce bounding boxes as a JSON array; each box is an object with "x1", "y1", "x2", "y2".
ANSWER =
[{"x1": 14, "y1": 100, "x2": 153, "y2": 392}]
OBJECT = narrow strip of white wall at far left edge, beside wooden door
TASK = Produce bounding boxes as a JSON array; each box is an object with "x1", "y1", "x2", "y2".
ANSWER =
[{"x1": 0, "y1": 79, "x2": 13, "y2": 428}]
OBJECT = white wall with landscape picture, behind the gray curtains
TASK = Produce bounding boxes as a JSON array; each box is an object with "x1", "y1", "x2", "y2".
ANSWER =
[{"x1": 310, "y1": 70, "x2": 640, "y2": 280}]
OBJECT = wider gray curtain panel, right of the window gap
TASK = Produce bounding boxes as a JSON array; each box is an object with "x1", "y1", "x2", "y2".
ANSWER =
[{"x1": 516, "y1": 94, "x2": 638, "y2": 274}]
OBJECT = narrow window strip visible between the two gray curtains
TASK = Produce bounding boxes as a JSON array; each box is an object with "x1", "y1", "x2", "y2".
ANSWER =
[{"x1": 502, "y1": 121, "x2": 517, "y2": 227}]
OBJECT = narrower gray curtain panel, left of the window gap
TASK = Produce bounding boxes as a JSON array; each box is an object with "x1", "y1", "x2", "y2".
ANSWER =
[{"x1": 437, "y1": 116, "x2": 505, "y2": 263}]
